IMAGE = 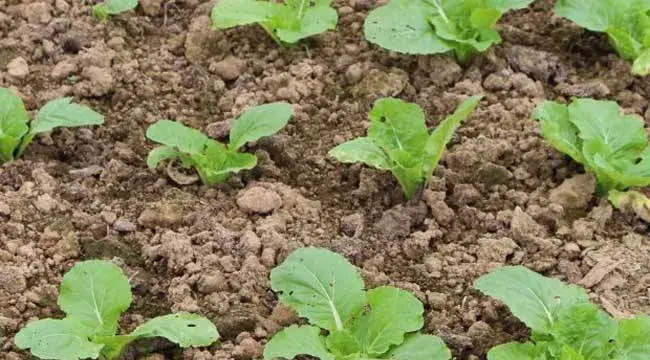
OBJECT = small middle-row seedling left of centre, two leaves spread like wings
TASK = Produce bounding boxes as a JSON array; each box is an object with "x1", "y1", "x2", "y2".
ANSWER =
[{"x1": 147, "y1": 103, "x2": 293, "y2": 185}]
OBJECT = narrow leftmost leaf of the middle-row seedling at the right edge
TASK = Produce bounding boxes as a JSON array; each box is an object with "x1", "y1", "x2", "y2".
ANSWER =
[{"x1": 531, "y1": 101, "x2": 585, "y2": 164}]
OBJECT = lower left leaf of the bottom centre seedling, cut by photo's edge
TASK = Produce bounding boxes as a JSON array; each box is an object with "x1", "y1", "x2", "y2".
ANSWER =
[{"x1": 264, "y1": 325, "x2": 335, "y2": 360}]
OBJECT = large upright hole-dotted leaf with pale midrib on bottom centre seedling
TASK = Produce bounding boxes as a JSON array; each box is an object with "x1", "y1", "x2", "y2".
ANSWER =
[{"x1": 271, "y1": 247, "x2": 366, "y2": 331}]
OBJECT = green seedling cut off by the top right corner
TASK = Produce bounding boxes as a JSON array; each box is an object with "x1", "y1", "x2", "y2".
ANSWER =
[{"x1": 555, "y1": 0, "x2": 650, "y2": 75}]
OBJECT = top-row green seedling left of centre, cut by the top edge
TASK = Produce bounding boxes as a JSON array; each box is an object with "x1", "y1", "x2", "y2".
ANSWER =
[{"x1": 212, "y1": 0, "x2": 338, "y2": 44}]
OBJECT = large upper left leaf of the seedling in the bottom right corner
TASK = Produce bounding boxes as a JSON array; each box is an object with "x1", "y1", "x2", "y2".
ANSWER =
[{"x1": 474, "y1": 266, "x2": 589, "y2": 333}]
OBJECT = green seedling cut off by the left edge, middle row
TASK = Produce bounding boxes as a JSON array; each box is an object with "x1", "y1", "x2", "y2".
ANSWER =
[{"x1": 0, "y1": 87, "x2": 104, "y2": 163}]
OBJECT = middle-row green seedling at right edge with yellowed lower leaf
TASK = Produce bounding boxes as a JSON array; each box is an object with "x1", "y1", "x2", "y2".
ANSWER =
[{"x1": 531, "y1": 99, "x2": 650, "y2": 219}]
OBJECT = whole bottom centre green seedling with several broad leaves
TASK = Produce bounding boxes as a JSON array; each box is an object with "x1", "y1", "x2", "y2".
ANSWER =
[{"x1": 264, "y1": 248, "x2": 451, "y2": 360}]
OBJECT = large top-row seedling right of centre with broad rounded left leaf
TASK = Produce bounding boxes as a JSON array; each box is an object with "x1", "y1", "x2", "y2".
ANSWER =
[{"x1": 364, "y1": 0, "x2": 533, "y2": 62}]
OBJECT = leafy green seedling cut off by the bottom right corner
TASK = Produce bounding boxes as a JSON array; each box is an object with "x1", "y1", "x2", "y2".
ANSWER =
[{"x1": 475, "y1": 266, "x2": 650, "y2": 360}]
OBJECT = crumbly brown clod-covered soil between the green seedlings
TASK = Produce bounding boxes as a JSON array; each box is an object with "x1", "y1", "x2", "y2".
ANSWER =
[{"x1": 0, "y1": 0, "x2": 650, "y2": 360}]
